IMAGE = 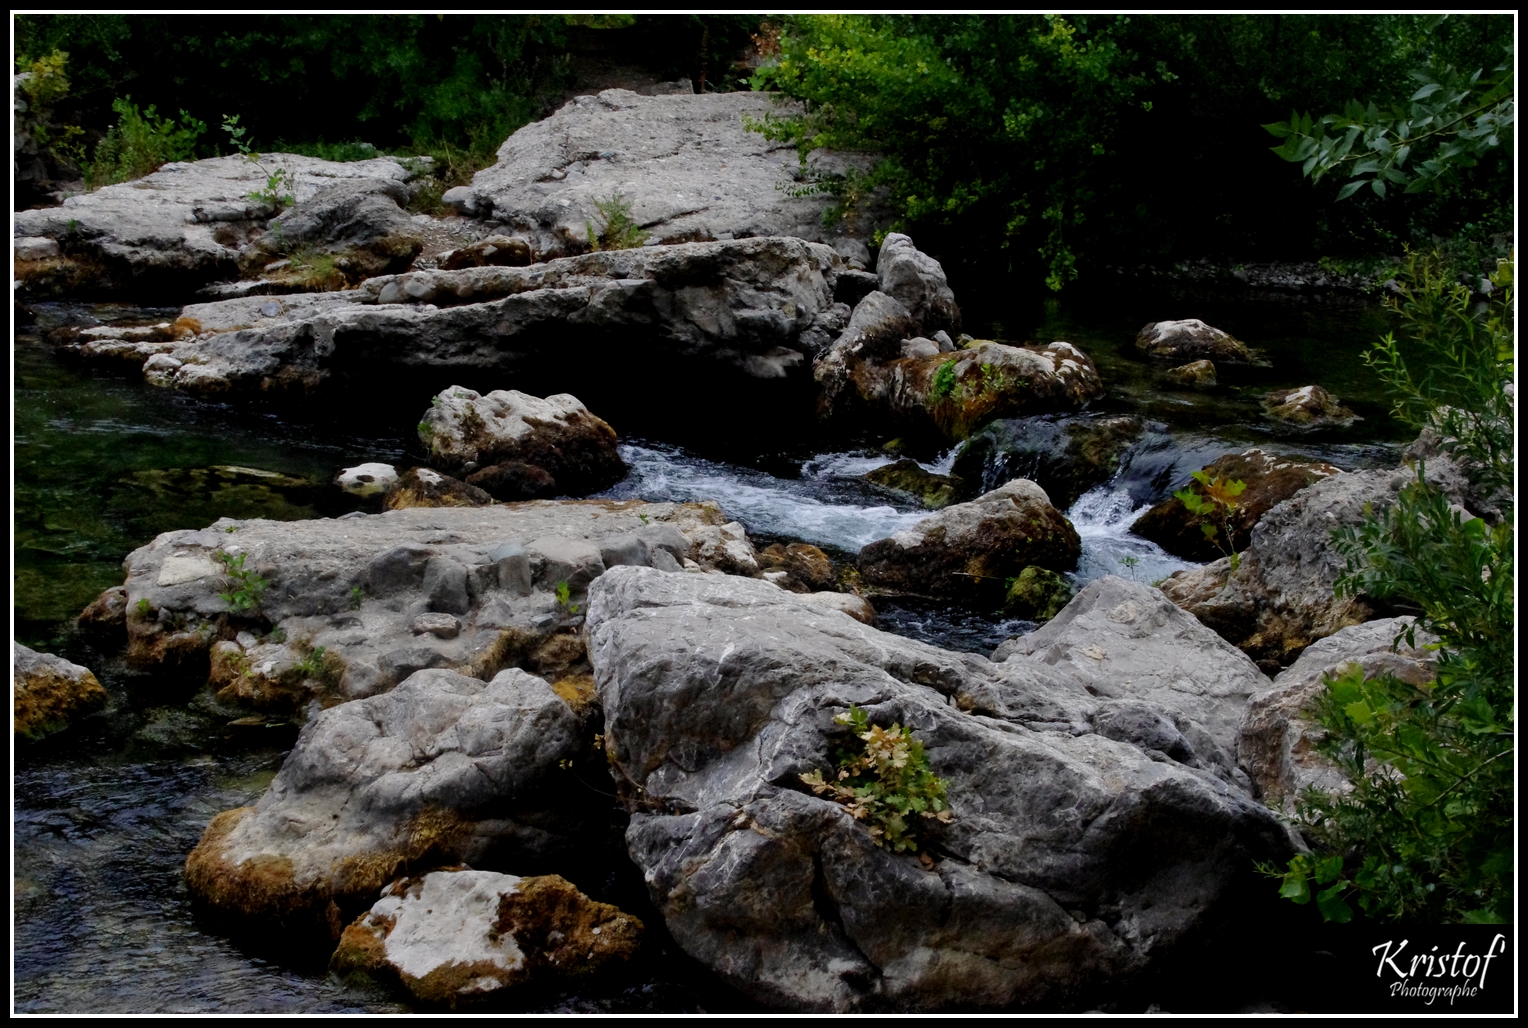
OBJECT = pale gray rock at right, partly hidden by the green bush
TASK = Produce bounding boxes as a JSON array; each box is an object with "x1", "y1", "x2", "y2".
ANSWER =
[{"x1": 1238, "y1": 617, "x2": 1436, "y2": 814}]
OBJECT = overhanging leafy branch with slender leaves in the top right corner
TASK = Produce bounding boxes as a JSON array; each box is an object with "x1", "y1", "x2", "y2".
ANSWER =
[{"x1": 1264, "y1": 41, "x2": 1516, "y2": 200}]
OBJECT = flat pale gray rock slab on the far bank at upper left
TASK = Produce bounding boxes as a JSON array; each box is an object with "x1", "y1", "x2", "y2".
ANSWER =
[{"x1": 14, "y1": 154, "x2": 416, "y2": 301}]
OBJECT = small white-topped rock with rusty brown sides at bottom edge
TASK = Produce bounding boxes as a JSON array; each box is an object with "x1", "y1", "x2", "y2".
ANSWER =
[{"x1": 330, "y1": 871, "x2": 643, "y2": 1010}]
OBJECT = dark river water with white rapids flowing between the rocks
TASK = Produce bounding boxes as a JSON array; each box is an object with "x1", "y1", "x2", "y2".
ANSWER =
[{"x1": 12, "y1": 281, "x2": 1406, "y2": 1013}]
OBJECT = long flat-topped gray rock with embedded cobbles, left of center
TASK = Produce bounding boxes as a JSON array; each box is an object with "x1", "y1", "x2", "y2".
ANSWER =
[{"x1": 124, "y1": 501, "x2": 756, "y2": 709}]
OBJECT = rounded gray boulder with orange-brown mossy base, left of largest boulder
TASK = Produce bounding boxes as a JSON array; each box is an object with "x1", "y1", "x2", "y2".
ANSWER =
[{"x1": 186, "y1": 669, "x2": 599, "y2": 938}]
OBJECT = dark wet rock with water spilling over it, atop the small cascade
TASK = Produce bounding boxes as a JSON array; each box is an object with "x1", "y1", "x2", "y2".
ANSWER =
[{"x1": 953, "y1": 415, "x2": 1144, "y2": 510}]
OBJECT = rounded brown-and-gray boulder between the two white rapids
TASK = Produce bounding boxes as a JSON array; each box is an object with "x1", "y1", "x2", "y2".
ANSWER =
[{"x1": 859, "y1": 478, "x2": 1082, "y2": 605}]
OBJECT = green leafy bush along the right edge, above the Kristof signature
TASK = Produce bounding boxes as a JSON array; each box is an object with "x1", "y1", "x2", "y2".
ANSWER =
[{"x1": 1277, "y1": 257, "x2": 1516, "y2": 923}]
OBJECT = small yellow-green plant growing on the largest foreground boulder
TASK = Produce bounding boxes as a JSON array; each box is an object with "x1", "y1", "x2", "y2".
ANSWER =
[{"x1": 801, "y1": 706, "x2": 953, "y2": 852}]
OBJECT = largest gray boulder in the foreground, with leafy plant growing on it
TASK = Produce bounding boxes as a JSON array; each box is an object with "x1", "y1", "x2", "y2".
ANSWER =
[{"x1": 588, "y1": 568, "x2": 1291, "y2": 1011}]
